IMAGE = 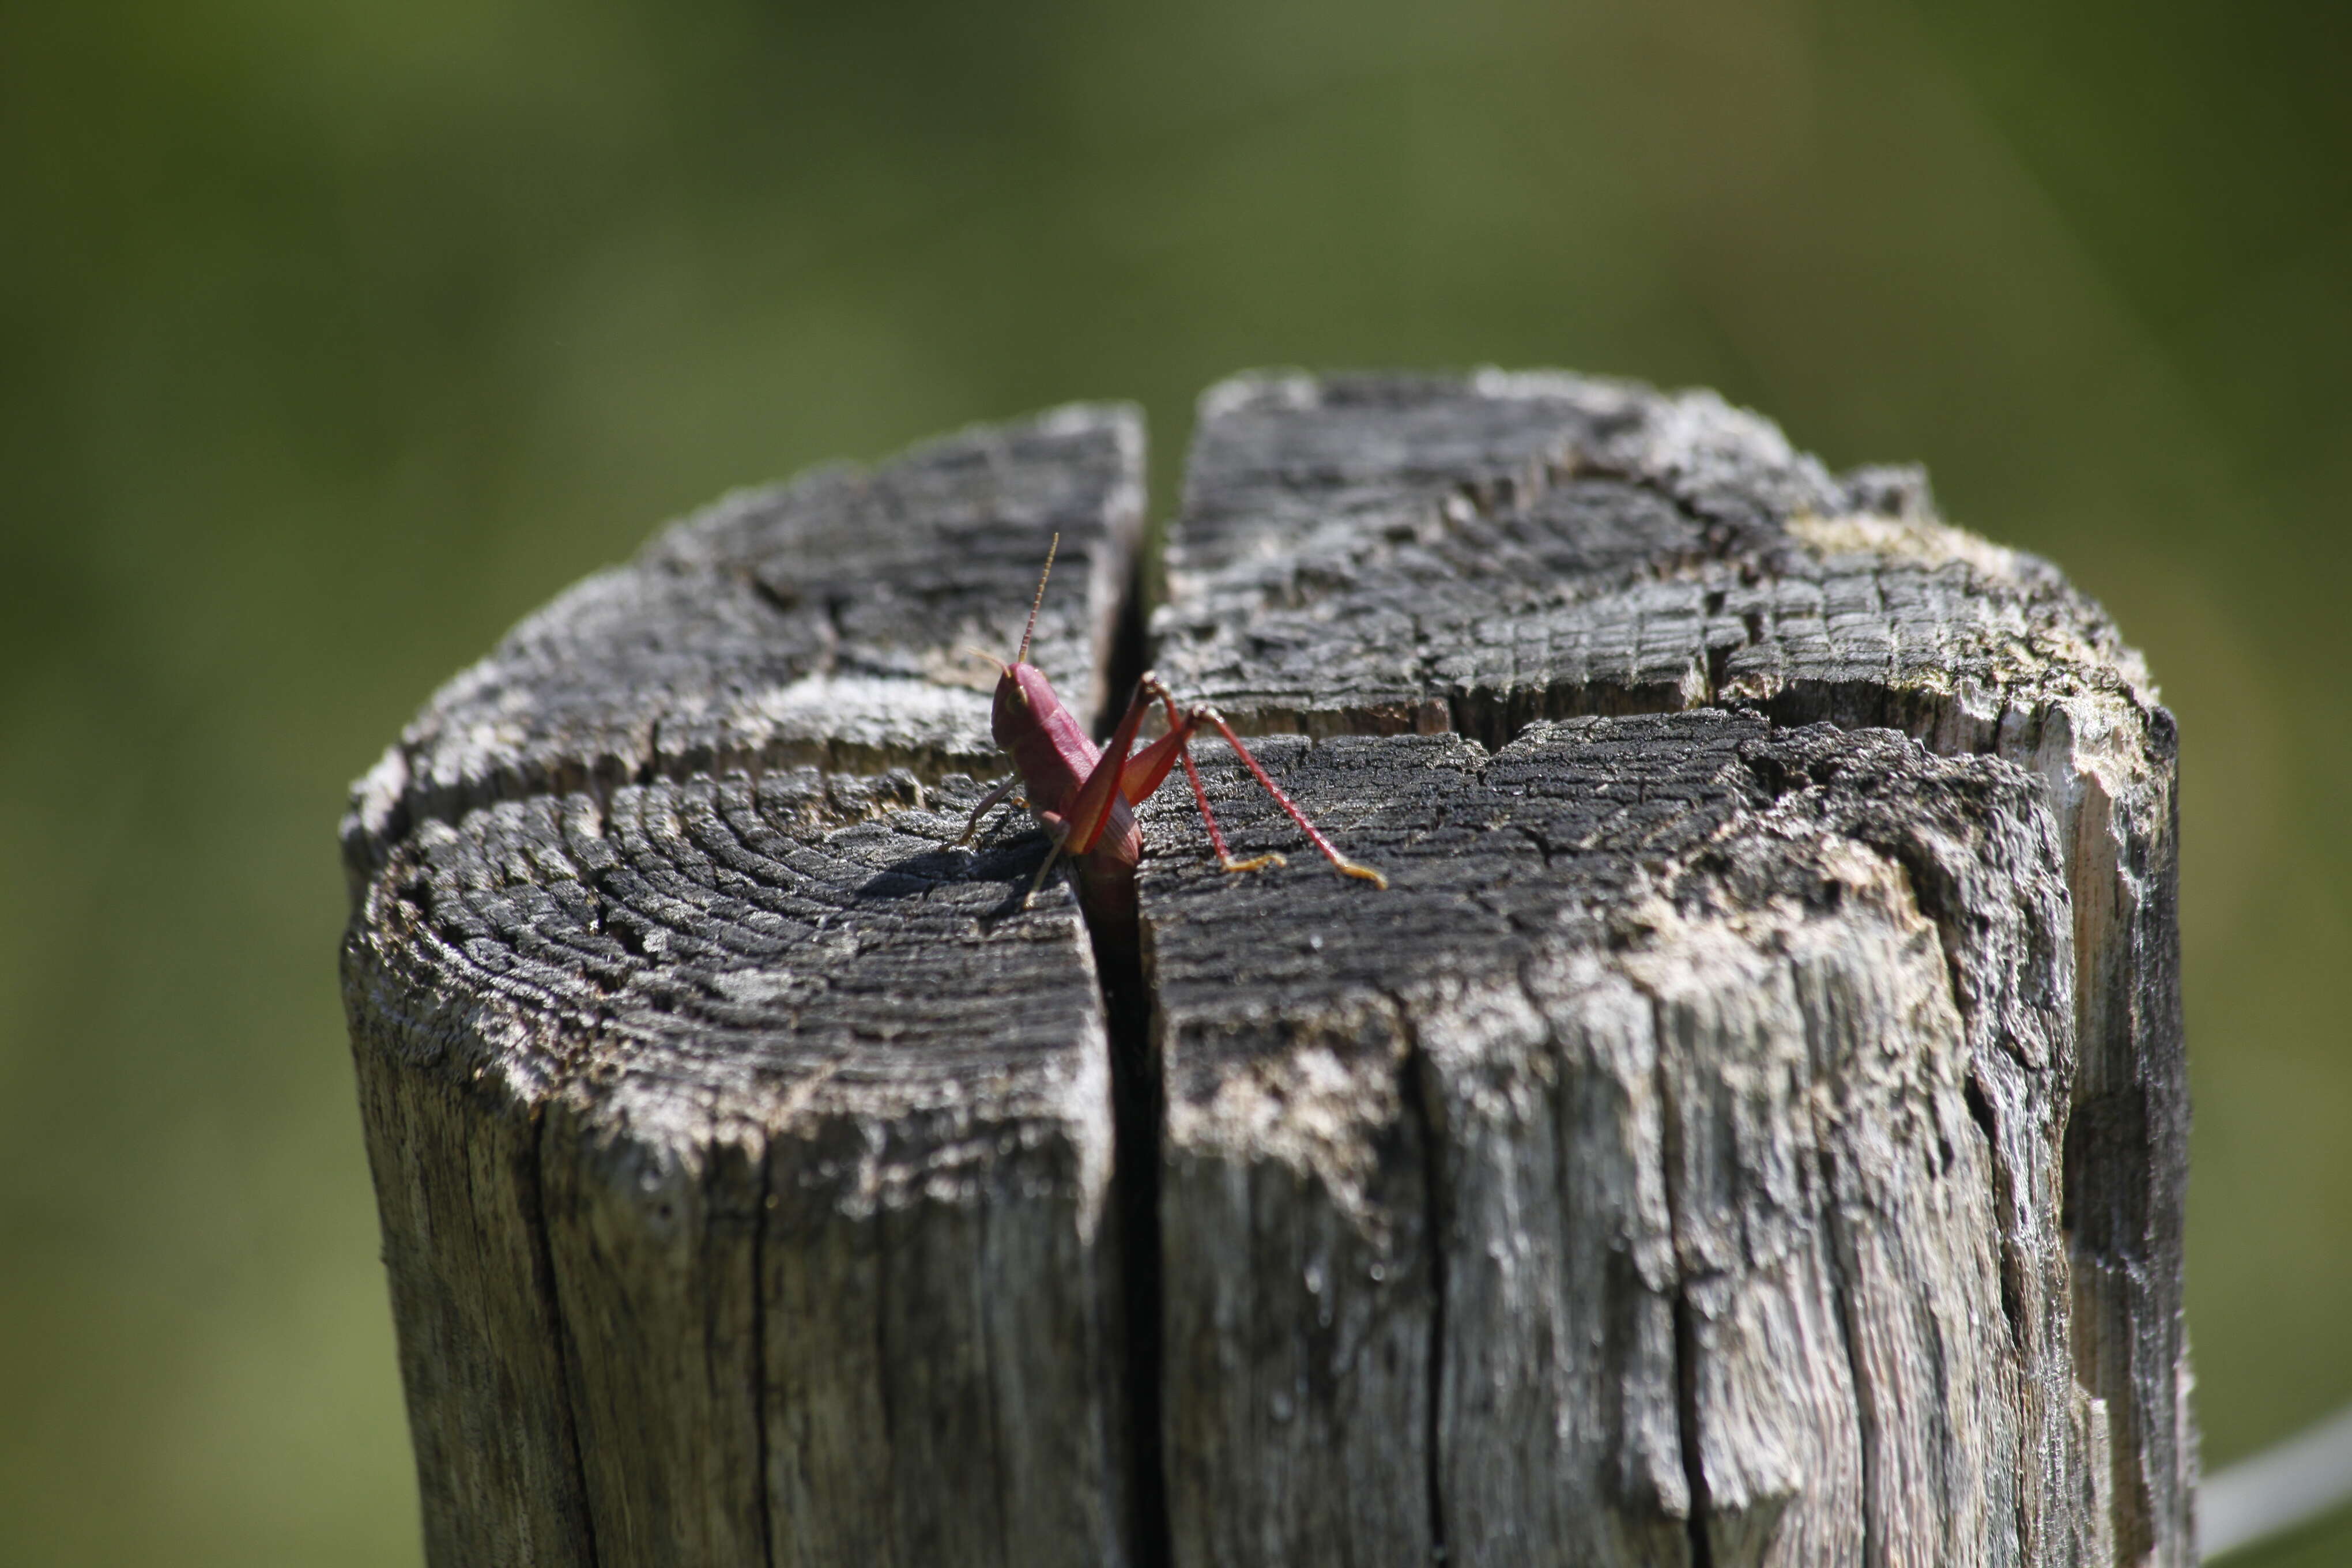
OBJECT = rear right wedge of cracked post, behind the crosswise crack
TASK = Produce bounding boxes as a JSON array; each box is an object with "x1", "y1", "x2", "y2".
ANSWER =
[{"x1": 1152, "y1": 371, "x2": 2195, "y2": 1563}]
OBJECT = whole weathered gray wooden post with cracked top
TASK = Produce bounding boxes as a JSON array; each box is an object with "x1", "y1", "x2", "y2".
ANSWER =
[{"x1": 344, "y1": 371, "x2": 2195, "y2": 1568}]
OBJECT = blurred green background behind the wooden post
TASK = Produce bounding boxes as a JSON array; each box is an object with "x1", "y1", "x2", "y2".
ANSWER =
[{"x1": 0, "y1": 0, "x2": 2352, "y2": 1563}]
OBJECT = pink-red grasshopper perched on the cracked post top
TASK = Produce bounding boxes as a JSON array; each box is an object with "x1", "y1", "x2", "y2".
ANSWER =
[{"x1": 958, "y1": 534, "x2": 1388, "y2": 905}]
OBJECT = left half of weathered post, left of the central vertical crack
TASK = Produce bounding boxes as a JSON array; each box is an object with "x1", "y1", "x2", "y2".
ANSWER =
[{"x1": 346, "y1": 409, "x2": 1143, "y2": 1566}]
